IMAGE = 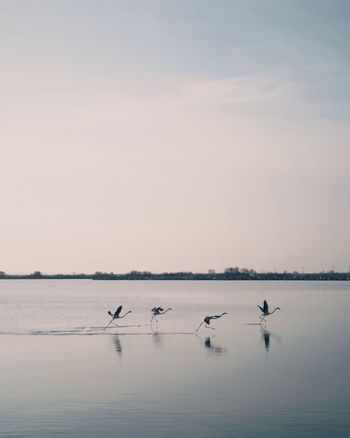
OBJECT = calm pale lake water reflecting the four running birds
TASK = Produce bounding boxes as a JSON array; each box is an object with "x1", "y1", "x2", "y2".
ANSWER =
[{"x1": 0, "y1": 280, "x2": 350, "y2": 438}]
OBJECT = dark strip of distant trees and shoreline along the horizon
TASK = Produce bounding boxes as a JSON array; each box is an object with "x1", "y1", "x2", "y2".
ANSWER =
[{"x1": 0, "y1": 266, "x2": 350, "y2": 281}]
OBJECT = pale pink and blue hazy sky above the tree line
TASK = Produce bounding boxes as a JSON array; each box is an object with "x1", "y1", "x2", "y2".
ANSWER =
[{"x1": 0, "y1": 0, "x2": 350, "y2": 273}]
